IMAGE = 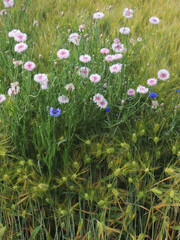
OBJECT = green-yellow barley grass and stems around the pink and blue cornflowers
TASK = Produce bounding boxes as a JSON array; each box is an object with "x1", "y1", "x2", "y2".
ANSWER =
[{"x1": 0, "y1": 0, "x2": 180, "y2": 240}]
